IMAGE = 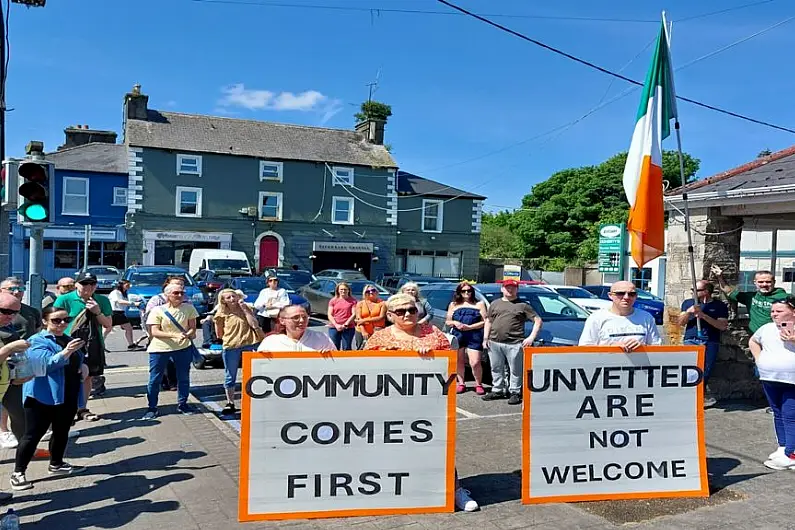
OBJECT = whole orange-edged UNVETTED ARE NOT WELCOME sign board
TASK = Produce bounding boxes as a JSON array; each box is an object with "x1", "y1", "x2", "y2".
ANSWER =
[{"x1": 522, "y1": 346, "x2": 709, "y2": 504}]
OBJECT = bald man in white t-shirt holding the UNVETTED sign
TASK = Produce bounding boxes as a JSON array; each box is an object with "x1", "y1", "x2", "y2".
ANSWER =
[{"x1": 580, "y1": 281, "x2": 662, "y2": 352}]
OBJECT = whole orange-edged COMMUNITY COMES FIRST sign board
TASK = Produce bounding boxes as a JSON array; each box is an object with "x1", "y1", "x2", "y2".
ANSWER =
[{"x1": 238, "y1": 351, "x2": 456, "y2": 521}]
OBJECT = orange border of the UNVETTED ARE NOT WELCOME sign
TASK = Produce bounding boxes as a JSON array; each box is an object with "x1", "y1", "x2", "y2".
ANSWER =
[{"x1": 522, "y1": 346, "x2": 709, "y2": 504}]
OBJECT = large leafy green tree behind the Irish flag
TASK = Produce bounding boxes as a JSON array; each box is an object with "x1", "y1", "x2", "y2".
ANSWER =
[{"x1": 500, "y1": 151, "x2": 700, "y2": 268}]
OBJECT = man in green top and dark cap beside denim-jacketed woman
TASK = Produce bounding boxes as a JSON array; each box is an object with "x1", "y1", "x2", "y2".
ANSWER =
[{"x1": 53, "y1": 270, "x2": 113, "y2": 421}]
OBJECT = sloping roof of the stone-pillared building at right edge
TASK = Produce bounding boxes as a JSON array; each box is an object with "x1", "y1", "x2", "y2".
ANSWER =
[{"x1": 666, "y1": 146, "x2": 795, "y2": 195}]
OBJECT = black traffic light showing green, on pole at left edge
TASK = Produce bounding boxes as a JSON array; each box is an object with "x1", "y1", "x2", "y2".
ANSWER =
[{"x1": 17, "y1": 159, "x2": 54, "y2": 223}]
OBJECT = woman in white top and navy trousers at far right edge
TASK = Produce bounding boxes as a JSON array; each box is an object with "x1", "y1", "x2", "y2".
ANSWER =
[{"x1": 748, "y1": 296, "x2": 795, "y2": 469}]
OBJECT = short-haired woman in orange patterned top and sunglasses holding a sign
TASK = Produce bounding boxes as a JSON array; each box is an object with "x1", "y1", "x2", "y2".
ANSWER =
[{"x1": 367, "y1": 293, "x2": 480, "y2": 512}]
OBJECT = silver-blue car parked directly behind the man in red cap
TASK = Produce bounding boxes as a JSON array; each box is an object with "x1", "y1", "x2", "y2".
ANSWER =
[{"x1": 420, "y1": 283, "x2": 588, "y2": 346}]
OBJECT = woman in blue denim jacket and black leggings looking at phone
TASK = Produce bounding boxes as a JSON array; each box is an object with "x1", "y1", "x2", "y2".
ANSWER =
[{"x1": 11, "y1": 306, "x2": 84, "y2": 491}]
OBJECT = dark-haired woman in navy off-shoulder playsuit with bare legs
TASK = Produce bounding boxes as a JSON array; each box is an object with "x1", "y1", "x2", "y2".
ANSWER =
[{"x1": 445, "y1": 282, "x2": 486, "y2": 396}]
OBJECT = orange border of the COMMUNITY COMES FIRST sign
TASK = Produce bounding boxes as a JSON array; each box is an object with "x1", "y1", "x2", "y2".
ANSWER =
[{"x1": 238, "y1": 350, "x2": 457, "y2": 522}]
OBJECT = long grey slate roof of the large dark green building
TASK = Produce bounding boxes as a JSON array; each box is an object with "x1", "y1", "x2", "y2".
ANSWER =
[{"x1": 126, "y1": 109, "x2": 397, "y2": 167}]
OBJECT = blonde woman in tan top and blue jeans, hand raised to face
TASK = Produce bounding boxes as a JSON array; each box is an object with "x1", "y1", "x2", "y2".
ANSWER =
[{"x1": 213, "y1": 289, "x2": 265, "y2": 416}]
